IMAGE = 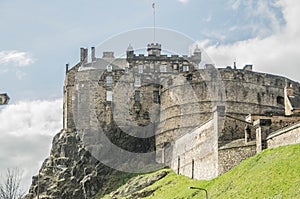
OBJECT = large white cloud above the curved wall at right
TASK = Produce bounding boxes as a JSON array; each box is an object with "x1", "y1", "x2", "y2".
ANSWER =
[{"x1": 198, "y1": 0, "x2": 300, "y2": 81}]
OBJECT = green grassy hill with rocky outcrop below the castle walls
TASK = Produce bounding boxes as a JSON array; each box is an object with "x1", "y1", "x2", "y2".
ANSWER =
[{"x1": 105, "y1": 144, "x2": 300, "y2": 199}]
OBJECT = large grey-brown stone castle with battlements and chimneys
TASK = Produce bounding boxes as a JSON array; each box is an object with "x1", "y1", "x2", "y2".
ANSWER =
[{"x1": 63, "y1": 43, "x2": 300, "y2": 179}]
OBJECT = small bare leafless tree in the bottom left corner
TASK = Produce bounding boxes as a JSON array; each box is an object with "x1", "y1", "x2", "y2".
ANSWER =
[{"x1": 0, "y1": 168, "x2": 25, "y2": 199}]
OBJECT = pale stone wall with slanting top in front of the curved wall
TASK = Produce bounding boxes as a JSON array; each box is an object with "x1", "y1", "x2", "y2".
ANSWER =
[{"x1": 169, "y1": 109, "x2": 219, "y2": 180}]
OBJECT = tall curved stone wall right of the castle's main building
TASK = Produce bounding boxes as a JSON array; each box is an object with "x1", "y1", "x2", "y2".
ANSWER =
[{"x1": 156, "y1": 69, "x2": 300, "y2": 152}]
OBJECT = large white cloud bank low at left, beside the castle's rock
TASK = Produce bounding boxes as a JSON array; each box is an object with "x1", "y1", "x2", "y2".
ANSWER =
[{"x1": 0, "y1": 99, "x2": 62, "y2": 191}]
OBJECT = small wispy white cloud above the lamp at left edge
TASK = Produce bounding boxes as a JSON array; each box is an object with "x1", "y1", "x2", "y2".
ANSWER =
[{"x1": 0, "y1": 50, "x2": 35, "y2": 67}]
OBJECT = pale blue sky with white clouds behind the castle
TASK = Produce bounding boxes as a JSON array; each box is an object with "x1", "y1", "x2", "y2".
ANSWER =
[{"x1": 0, "y1": 0, "x2": 300, "y2": 193}]
